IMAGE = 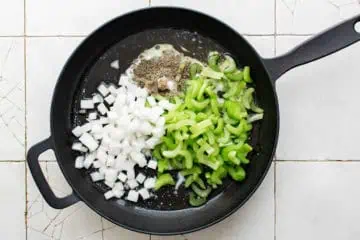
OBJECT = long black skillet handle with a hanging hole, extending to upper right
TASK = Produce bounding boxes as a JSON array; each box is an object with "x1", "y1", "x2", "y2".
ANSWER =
[{"x1": 264, "y1": 15, "x2": 360, "y2": 82}]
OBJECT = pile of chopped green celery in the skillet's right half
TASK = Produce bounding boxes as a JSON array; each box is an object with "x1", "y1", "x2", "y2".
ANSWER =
[{"x1": 153, "y1": 52, "x2": 263, "y2": 206}]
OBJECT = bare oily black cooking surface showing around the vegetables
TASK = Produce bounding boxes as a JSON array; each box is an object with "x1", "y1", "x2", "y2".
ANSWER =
[{"x1": 71, "y1": 28, "x2": 259, "y2": 210}]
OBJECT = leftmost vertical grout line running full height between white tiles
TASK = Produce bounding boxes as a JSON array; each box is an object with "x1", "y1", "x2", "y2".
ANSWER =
[{"x1": 24, "y1": 0, "x2": 28, "y2": 240}]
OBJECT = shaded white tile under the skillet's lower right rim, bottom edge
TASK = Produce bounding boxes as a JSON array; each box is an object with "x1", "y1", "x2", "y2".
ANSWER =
[{"x1": 151, "y1": 166, "x2": 274, "y2": 240}]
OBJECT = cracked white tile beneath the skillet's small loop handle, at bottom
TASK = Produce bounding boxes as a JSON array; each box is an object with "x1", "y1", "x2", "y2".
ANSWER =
[{"x1": 27, "y1": 162, "x2": 149, "y2": 240}]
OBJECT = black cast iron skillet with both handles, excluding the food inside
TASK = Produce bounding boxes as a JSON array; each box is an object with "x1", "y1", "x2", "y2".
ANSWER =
[{"x1": 27, "y1": 7, "x2": 360, "y2": 235}]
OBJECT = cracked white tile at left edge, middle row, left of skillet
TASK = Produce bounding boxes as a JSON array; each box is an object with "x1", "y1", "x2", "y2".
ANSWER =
[{"x1": 0, "y1": 38, "x2": 25, "y2": 160}]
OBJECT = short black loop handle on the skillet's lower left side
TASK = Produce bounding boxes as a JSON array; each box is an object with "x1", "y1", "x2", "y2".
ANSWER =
[{"x1": 26, "y1": 138, "x2": 79, "y2": 209}]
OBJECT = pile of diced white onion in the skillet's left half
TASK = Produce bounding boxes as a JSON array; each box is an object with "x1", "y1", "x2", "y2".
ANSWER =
[{"x1": 72, "y1": 71, "x2": 173, "y2": 202}]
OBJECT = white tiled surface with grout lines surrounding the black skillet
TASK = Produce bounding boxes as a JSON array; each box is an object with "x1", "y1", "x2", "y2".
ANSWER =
[{"x1": 0, "y1": 0, "x2": 360, "y2": 240}]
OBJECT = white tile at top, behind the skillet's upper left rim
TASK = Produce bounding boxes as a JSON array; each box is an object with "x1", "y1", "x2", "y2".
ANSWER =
[{"x1": 26, "y1": 0, "x2": 149, "y2": 35}]
